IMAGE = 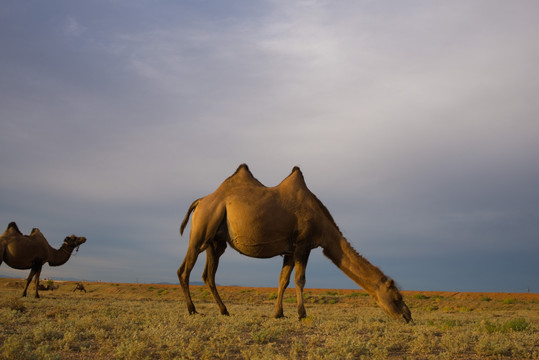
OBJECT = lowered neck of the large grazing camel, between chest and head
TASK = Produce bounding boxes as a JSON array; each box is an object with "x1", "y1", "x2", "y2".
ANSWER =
[{"x1": 324, "y1": 236, "x2": 387, "y2": 295}]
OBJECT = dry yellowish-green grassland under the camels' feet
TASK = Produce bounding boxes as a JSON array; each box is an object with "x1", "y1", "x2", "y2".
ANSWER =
[{"x1": 0, "y1": 278, "x2": 539, "y2": 359}]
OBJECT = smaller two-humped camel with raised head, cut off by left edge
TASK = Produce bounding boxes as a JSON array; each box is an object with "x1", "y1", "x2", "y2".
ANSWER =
[{"x1": 0, "y1": 222, "x2": 86, "y2": 298}]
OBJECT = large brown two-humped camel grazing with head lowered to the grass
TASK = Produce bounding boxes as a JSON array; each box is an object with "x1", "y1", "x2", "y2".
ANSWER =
[{"x1": 178, "y1": 164, "x2": 412, "y2": 322}]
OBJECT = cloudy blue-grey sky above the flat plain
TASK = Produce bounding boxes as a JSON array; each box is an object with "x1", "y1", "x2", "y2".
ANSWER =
[{"x1": 0, "y1": 0, "x2": 539, "y2": 292}]
